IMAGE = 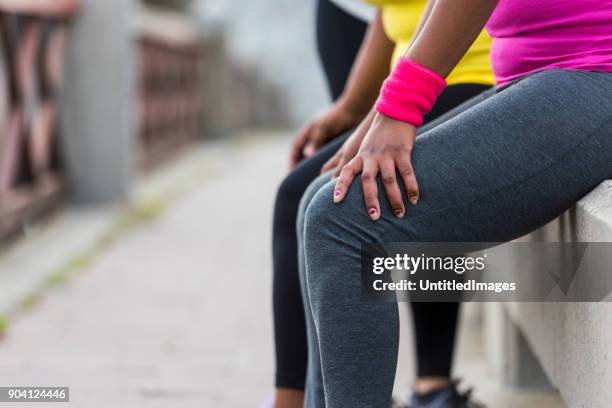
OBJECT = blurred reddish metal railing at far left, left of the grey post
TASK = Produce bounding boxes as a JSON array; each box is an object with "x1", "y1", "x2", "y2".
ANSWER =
[{"x1": 0, "y1": 0, "x2": 78, "y2": 238}]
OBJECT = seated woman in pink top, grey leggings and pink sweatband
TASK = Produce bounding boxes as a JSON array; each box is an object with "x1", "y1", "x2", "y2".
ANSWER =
[{"x1": 298, "y1": 0, "x2": 612, "y2": 408}]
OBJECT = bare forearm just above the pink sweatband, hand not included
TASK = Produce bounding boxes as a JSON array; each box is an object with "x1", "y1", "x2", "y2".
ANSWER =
[{"x1": 406, "y1": 0, "x2": 498, "y2": 77}]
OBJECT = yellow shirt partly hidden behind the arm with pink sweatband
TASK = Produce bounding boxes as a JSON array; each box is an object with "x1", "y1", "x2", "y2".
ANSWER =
[{"x1": 366, "y1": 0, "x2": 495, "y2": 85}]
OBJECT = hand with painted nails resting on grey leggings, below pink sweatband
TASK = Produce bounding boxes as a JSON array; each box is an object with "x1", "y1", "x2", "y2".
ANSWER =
[{"x1": 334, "y1": 114, "x2": 419, "y2": 220}]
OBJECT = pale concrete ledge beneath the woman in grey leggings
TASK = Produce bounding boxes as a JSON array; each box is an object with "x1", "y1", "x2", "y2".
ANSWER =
[{"x1": 486, "y1": 180, "x2": 612, "y2": 408}]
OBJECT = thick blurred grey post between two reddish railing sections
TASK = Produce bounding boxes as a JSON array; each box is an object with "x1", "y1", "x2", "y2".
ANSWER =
[{"x1": 61, "y1": 0, "x2": 138, "y2": 203}]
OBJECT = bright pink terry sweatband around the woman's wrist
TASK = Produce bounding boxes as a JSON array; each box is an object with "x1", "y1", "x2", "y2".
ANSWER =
[{"x1": 376, "y1": 57, "x2": 446, "y2": 127}]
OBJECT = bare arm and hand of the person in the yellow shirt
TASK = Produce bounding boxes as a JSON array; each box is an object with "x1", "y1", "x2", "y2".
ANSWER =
[{"x1": 290, "y1": 12, "x2": 394, "y2": 168}]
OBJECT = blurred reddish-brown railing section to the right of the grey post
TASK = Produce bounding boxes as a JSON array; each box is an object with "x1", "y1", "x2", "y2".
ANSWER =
[{"x1": 137, "y1": 11, "x2": 204, "y2": 168}]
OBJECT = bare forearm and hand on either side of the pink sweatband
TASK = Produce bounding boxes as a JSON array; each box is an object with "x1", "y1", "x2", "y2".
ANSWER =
[{"x1": 334, "y1": 0, "x2": 497, "y2": 220}]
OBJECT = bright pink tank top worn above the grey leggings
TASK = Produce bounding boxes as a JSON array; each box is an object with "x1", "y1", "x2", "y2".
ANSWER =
[{"x1": 487, "y1": 0, "x2": 612, "y2": 84}]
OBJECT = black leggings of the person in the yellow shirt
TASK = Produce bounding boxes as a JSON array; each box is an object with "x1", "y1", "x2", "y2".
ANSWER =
[{"x1": 273, "y1": 84, "x2": 488, "y2": 389}]
